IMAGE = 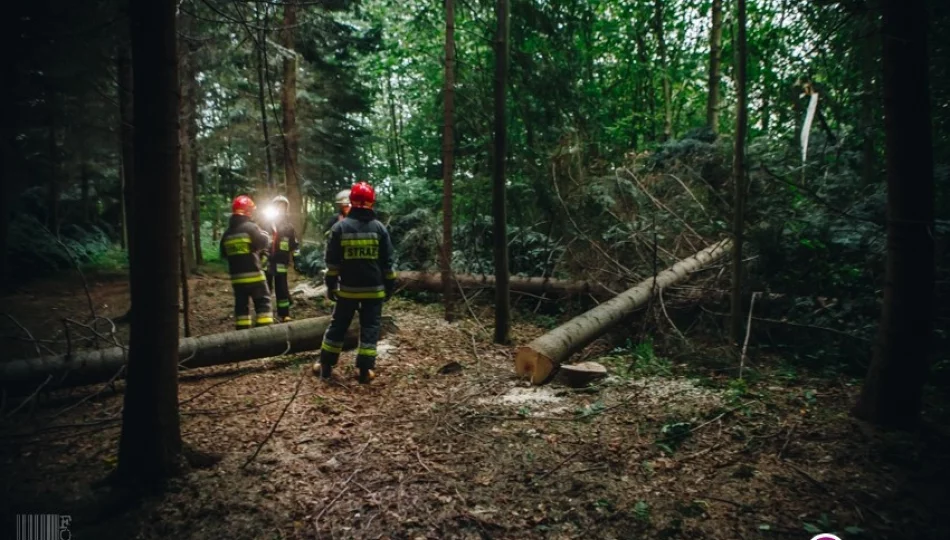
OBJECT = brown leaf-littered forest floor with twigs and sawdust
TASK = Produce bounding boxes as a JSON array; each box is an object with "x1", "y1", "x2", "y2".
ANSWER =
[{"x1": 0, "y1": 272, "x2": 950, "y2": 540}]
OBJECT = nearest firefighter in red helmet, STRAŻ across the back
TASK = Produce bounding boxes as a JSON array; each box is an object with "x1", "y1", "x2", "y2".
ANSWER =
[{"x1": 314, "y1": 182, "x2": 396, "y2": 384}]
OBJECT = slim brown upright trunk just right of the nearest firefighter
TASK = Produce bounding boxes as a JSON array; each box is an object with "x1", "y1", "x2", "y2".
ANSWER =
[{"x1": 441, "y1": 0, "x2": 455, "y2": 321}]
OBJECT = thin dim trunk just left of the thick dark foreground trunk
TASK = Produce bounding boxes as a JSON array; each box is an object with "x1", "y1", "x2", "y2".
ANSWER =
[{"x1": 116, "y1": 36, "x2": 135, "y2": 261}]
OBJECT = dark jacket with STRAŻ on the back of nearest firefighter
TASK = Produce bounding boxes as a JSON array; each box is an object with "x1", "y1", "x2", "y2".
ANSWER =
[{"x1": 326, "y1": 208, "x2": 396, "y2": 300}]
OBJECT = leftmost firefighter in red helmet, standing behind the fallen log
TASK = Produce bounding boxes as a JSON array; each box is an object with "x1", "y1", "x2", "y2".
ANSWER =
[{"x1": 221, "y1": 195, "x2": 274, "y2": 330}]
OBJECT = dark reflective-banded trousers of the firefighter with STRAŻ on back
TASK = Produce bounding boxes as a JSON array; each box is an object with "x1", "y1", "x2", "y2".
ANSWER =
[{"x1": 320, "y1": 298, "x2": 383, "y2": 369}]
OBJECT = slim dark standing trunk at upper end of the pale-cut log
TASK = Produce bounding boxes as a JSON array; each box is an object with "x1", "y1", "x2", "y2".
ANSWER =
[{"x1": 729, "y1": 0, "x2": 749, "y2": 344}]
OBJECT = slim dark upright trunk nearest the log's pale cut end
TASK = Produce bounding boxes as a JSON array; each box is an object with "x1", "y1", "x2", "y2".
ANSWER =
[{"x1": 492, "y1": 0, "x2": 511, "y2": 343}]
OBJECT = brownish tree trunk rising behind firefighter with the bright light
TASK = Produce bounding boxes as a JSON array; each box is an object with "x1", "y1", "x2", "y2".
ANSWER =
[{"x1": 280, "y1": 0, "x2": 306, "y2": 233}]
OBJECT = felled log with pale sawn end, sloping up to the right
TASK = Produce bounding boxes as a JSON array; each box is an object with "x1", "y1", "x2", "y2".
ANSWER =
[{"x1": 515, "y1": 240, "x2": 732, "y2": 384}]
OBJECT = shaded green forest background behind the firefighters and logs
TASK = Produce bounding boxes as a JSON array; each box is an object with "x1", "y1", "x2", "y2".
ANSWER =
[{"x1": 0, "y1": 0, "x2": 950, "y2": 382}]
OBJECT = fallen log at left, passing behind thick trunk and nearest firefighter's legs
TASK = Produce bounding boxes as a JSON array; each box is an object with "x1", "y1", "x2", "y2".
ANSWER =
[{"x1": 0, "y1": 317, "x2": 392, "y2": 393}]
